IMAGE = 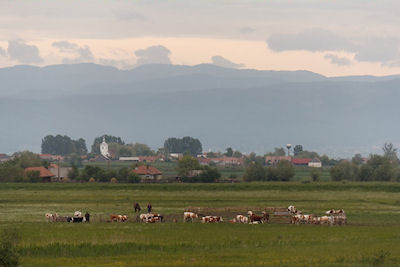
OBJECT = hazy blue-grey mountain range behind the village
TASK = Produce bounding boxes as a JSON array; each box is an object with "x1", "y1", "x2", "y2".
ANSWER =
[{"x1": 0, "y1": 64, "x2": 400, "y2": 156}]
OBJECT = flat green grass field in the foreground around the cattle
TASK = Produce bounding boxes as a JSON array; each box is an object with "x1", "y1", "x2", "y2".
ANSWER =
[{"x1": 0, "y1": 182, "x2": 400, "y2": 266}]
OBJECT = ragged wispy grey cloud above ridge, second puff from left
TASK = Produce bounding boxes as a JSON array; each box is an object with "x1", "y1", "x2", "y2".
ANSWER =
[{"x1": 52, "y1": 41, "x2": 94, "y2": 64}]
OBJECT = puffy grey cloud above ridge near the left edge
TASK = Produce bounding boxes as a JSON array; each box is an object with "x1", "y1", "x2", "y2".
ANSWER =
[{"x1": 7, "y1": 39, "x2": 43, "y2": 63}]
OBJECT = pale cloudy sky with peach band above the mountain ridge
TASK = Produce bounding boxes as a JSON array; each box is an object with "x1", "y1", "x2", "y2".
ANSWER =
[{"x1": 0, "y1": 0, "x2": 400, "y2": 76}]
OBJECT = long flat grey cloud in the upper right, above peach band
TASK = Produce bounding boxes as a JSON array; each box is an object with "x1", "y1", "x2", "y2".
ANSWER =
[{"x1": 267, "y1": 28, "x2": 354, "y2": 52}]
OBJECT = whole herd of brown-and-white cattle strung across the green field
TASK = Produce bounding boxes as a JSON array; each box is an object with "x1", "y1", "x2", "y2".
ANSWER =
[{"x1": 45, "y1": 206, "x2": 347, "y2": 225}]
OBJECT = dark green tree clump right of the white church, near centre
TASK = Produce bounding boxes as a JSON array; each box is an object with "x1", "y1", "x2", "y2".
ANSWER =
[{"x1": 164, "y1": 136, "x2": 203, "y2": 156}]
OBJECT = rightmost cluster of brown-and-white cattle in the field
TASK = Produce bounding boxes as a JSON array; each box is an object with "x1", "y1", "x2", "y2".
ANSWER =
[{"x1": 288, "y1": 206, "x2": 347, "y2": 225}]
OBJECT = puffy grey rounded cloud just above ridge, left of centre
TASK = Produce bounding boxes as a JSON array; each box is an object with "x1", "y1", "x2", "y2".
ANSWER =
[{"x1": 135, "y1": 45, "x2": 171, "y2": 65}]
